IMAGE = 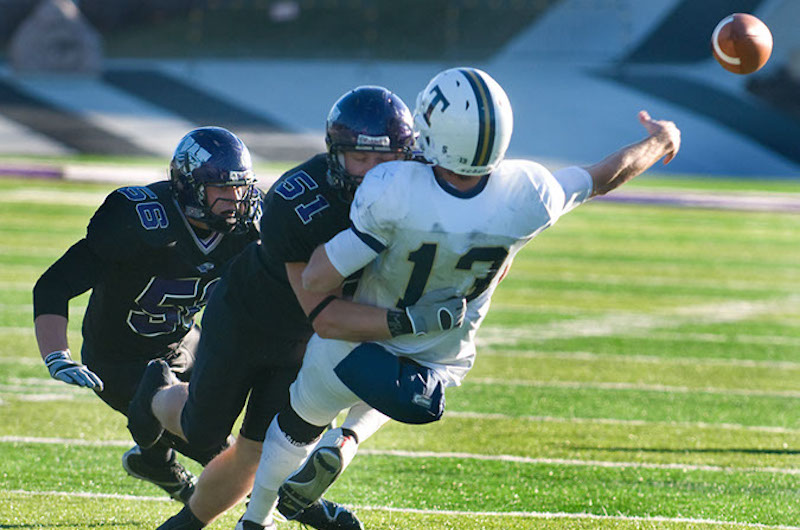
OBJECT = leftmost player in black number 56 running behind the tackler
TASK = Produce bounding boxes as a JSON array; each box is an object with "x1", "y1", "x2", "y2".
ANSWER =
[{"x1": 33, "y1": 127, "x2": 261, "y2": 502}]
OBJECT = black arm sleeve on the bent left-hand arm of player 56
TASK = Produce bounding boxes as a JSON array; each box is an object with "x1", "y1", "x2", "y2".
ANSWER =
[{"x1": 33, "y1": 239, "x2": 102, "y2": 318}]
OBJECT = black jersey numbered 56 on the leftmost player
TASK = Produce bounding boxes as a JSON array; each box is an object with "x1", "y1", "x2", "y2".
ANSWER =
[{"x1": 34, "y1": 181, "x2": 258, "y2": 362}]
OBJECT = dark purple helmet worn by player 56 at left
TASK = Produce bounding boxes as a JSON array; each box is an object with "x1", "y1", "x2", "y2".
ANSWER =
[{"x1": 169, "y1": 127, "x2": 261, "y2": 232}]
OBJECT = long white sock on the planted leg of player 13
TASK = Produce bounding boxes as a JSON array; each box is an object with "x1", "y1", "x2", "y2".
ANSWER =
[{"x1": 244, "y1": 416, "x2": 314, "y2": 526}]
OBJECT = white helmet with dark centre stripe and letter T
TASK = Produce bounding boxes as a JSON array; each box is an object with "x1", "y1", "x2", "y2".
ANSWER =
[{"x1": 414, "y1": 68, "x2": 514, "y2": 175}]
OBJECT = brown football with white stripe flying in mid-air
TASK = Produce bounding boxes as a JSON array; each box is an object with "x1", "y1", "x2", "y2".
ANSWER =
[{"x1": 711, "y1": 13, "x2": 772, "y2": 74}]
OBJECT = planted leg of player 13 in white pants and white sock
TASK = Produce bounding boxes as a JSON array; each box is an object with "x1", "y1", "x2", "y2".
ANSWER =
[{"x1": 243, "y1": 336, "x2": 360, "y2": 528}]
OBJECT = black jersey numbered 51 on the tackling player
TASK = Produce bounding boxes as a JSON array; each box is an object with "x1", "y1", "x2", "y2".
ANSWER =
[{"x1": 223, "y1": 154, "x2": 350, "y2": 338}]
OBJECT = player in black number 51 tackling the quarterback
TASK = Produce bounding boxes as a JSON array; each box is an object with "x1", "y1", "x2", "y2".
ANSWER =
[{"x1": 128, "y1": 86, "x2": 466, "y2": 530}]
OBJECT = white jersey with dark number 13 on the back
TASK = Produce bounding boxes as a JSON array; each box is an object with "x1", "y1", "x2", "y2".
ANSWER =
[{"x1": 326, "y1": 160, "x2": 592, "y2": 385}]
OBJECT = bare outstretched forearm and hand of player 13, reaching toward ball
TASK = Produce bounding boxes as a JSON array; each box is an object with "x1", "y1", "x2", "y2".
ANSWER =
[{"x1": 585, "y1": 110, "x2": 681, "y2": 196}]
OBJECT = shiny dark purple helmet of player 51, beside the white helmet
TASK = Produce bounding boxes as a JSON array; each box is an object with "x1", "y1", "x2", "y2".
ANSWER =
[{"x1": 325, "y1": 86, "x2": 416, "y2": 193}]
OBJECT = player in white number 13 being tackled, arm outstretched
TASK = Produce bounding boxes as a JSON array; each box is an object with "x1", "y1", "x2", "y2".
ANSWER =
[{"x1": 240, "y1": 68, "x2": 680, "y2": 528}]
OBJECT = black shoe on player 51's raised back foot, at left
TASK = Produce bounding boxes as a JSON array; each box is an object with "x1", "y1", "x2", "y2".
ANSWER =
[{"x1": 128, "y1": 359, "x2": 176, "y2": 449}]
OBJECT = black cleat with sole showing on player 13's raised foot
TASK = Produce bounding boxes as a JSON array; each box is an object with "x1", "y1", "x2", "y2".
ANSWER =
[{"x1": 278, "y1": 447, "x2": 342, "y2": 520}]
